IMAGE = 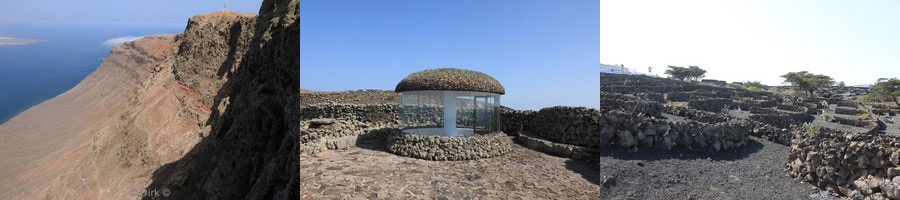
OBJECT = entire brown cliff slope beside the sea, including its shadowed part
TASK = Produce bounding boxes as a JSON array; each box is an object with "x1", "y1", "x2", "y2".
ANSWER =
[{"x1": 0, "y1": 0, "x2": 300, "y2": 199}]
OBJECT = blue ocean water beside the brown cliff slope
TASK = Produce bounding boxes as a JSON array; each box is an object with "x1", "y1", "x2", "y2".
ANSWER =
[{"x1": 0, "y1": 22, "x2": 184, "y2": 123}]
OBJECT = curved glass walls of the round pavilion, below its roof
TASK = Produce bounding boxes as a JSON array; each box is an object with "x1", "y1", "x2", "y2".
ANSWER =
[{"x1": 400, "y1": 90, "x2": 500, "y2": 136}]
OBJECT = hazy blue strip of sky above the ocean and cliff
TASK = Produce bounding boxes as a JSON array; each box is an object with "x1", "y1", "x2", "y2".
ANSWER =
[{"x1": 0, "y1": 0, "x2": 262, "y2": 24}]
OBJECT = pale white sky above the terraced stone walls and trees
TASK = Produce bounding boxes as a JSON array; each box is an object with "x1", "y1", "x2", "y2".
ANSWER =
[{"x1": 600, "y1": 0, "x2": 900, "y2": 85}]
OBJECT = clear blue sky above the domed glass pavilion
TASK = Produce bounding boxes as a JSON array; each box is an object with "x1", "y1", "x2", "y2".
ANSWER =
[{"x1": 300, "y1": 0, "x2": 600, "y2": 109}]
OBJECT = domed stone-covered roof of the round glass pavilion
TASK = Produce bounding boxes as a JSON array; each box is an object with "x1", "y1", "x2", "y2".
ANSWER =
[{"x1": 394, "y1": 68, "x2": 506, "y2": 94}]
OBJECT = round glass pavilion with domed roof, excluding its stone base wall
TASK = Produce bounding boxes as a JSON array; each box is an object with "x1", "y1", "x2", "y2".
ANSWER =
[{"x1": 394, "y1": 68, "x2": 506, "y2": 136}]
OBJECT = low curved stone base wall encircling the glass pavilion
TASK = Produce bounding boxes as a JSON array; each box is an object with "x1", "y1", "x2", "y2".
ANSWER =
[{"x1": 387, "y1": 132, "x2": 512, "y2": 160}]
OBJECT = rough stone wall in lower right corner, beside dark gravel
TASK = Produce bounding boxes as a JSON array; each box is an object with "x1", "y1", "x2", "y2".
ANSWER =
[{"x1": 785, "y1": 129, "x2": 900, "y2": 199}]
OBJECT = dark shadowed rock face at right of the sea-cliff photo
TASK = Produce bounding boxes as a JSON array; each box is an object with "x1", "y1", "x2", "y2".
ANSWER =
[{"x1": 148, "y1": 0, "x2": 300, "y2": 199}]
